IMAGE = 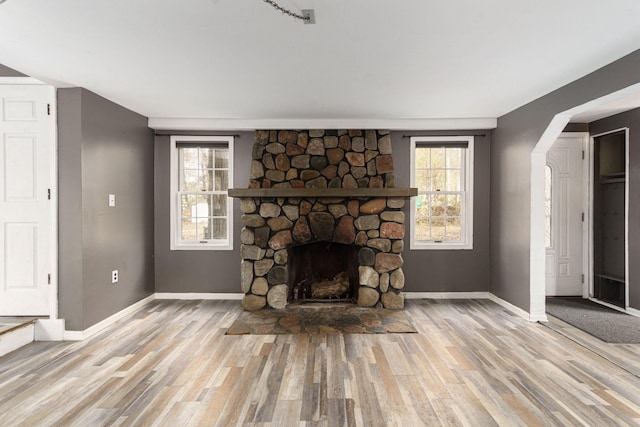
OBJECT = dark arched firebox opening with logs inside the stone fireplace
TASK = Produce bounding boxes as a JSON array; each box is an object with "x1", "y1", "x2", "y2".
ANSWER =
[{"x1": 288, "y1": 242, "x2": 359, "y2": 304}]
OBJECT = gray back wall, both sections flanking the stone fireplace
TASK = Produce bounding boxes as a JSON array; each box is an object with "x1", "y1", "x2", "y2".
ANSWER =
[{"x1": 155, "y1": 131, "x2": 490, "y2": 293}]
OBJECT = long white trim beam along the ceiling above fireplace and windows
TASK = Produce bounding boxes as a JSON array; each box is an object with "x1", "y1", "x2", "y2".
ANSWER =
[{"x1": 149, "y1": 117, "x2": 498, "y2": 131}]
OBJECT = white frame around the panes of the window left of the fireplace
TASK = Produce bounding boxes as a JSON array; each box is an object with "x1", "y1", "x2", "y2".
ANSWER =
[{"x1": 169, "y1": 135, "x2": 234, "y2": 251}]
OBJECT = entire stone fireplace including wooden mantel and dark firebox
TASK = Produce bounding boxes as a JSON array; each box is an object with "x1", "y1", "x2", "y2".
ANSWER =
[{"x1": 229, "y1": 130, "x2": 416, "y2": 310}]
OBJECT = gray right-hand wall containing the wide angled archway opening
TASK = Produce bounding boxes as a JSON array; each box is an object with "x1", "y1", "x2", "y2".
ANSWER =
[{"x1": 490, "y1": 51, "x2": 640, "y2": 311}]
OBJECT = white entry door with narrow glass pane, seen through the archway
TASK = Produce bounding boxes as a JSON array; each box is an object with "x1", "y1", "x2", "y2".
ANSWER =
[{"x1": 545, "y1": 136, "x2": 584, "y2": 296}]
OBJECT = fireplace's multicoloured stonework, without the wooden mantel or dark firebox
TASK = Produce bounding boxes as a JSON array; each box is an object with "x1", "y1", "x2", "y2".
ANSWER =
[{"x1": 240, "y1": 130, "x2": 405, "y2": 310}]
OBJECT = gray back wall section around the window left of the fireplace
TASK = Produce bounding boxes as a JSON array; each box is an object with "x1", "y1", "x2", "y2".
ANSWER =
[{"x1": 155, "y1": 131, "x2": 254, "y2": 293}]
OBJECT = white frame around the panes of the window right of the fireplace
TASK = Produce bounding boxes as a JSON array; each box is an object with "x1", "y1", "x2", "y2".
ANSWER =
[{"x1": 409, "y1": 136, "x2": 474, "y2": 250}]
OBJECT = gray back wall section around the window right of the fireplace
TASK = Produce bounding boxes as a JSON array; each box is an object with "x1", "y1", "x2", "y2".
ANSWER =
[{"x1": 391, "y1": 130, "x2": 491, "y2": 292}]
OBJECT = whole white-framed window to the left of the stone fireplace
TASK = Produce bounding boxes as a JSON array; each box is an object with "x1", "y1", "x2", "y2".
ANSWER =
[{"x1": 170, "y1": 136, "x2": 233, "y2": 250}]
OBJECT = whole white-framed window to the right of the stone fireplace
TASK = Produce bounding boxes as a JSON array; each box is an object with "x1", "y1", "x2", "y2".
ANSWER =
[{"x1": 410, "y1": 136, "x2": 473, "y2": 249}]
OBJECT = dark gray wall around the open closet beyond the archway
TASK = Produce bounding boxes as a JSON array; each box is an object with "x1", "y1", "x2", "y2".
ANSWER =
[{"x1": 589, "y1": 108, "x2": 640, "y2": 309}]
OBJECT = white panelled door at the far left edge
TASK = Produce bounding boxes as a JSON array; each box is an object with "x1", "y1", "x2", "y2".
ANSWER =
[{"x1": 0, "y1": 84, "x2": 55, "y2": 316}]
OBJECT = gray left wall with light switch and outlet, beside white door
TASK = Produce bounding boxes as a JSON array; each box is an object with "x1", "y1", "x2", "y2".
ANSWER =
[{"x1": 58, "y1": 88, "x2": 154, "y2": 330}]
